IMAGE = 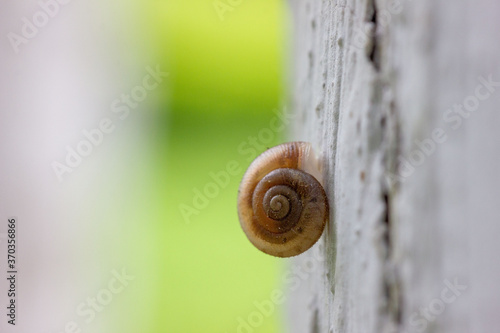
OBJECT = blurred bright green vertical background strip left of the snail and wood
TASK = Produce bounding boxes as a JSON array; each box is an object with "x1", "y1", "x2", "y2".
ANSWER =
[{"x1": 149, "y1": 0, "x2": 288, "y2": 332}]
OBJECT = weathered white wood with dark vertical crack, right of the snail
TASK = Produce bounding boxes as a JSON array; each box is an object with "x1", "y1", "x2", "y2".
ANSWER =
[{"x1": 288, "y1": 0, "x2": 500, "y2": 333}]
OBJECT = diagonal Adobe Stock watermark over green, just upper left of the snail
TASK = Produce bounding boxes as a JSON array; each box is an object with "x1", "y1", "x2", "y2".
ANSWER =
[{"x1": 179, "y1": 110, "x2": 295, "y2": 224}]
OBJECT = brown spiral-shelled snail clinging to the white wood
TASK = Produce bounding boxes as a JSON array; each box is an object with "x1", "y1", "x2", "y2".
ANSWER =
[{"x1": 238, "y1": 142, "x2": 329, "y2": 257}]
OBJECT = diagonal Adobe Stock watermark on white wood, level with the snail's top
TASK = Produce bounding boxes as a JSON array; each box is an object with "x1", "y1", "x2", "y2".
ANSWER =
[{"x1": 386, "y1": 74, "x2": 500, "y2": 185}]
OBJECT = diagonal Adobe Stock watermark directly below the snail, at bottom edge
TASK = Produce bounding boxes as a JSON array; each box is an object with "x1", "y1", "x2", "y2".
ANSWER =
[{"x1": 228, "y1": 244, "x2": 325, "y2": 333}]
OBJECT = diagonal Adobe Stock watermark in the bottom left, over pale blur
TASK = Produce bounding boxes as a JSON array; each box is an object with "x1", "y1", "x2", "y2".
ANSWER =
[{"x1": 44, "y1": 268, "x2": 135, "y2": 333}]
